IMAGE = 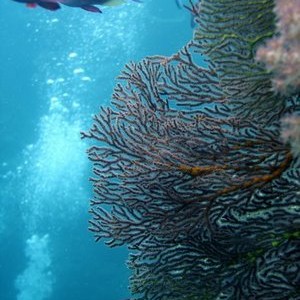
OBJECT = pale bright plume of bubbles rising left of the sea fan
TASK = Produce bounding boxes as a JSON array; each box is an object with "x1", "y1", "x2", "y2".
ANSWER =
[{"x1": 0, "y1": 4, "x2": 148, "y2": 300}]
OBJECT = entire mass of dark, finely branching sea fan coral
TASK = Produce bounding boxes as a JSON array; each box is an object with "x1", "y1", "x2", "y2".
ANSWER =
[{"x1": 82, "y1": 0, "x2": 300, "y2": 300}]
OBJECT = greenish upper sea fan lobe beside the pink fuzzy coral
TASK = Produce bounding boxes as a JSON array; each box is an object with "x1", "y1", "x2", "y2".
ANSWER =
[{"x1": 194, "y1": 0, "x2": 283, "y2": 122}]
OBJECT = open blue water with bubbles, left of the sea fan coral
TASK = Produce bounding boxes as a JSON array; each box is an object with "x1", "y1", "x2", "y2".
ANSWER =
[{"x1": 0, "y1": 0, "x2": 192, "y2": 300}]
